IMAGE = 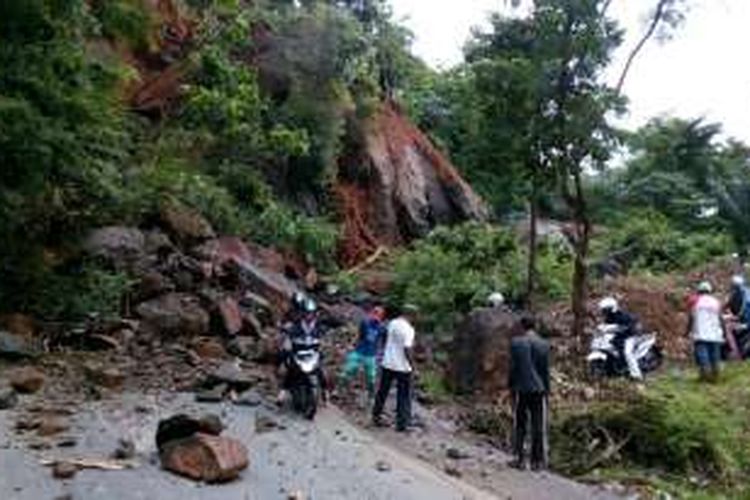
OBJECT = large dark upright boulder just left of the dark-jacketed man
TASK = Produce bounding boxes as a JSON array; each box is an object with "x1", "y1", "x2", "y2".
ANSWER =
[{"x1": 451, "y1": 308, "x2": 518, "y2": 397}]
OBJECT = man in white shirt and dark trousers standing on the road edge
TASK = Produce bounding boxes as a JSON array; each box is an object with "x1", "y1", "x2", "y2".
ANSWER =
[{"x1": 372, "y1": 305, "x2": 417, "y2": 432}]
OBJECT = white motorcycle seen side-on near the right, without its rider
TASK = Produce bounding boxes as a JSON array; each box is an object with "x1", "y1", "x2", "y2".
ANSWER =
[{"x1": 586, "y1": 325, "x2": 663, "y2": 378}]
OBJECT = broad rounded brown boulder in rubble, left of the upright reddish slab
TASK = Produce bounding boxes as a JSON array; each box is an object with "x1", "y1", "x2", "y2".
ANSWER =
[{"x1": 136, "y1": 293, "x2": 210, "y2": 336}]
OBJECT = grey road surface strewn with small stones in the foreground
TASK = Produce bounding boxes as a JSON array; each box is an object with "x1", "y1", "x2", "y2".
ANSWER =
[{"x1": 0, "y1": 395, "x2": 502, "y2": 500}]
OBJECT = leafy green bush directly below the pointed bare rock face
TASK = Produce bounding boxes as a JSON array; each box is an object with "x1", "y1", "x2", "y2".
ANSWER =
[{"x1": 390, "y1": 223, "x2": 570, "y2": 333}]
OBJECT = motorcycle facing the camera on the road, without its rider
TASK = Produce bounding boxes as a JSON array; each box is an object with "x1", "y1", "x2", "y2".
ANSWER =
[{"x1": 284, "y1": 330, "x2": 322, "y2": 420}]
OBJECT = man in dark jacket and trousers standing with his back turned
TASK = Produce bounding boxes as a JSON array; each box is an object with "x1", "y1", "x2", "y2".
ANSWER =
[{"x1": 508, "y1": 316, "x2": 549, "y2": 470}]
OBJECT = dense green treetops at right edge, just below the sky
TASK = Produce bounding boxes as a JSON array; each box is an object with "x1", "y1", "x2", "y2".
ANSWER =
[{"x1": 589, "y1": 118, "x2": 750, "y2": 252}]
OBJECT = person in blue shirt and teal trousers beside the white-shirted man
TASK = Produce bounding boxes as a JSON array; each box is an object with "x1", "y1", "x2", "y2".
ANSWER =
[{"x1": 339, "y1": 306, "x2": 385, "y2": 398}]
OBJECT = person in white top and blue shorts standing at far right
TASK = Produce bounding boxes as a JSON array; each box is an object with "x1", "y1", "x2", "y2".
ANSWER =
[{"x1": 687, "y1": 281, "x2": 726, "y2": 382}]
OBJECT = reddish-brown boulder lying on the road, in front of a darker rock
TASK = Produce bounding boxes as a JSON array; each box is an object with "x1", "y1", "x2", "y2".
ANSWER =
[{"x1": 159, "y1": 433, "x2": 250, "y2": 483}]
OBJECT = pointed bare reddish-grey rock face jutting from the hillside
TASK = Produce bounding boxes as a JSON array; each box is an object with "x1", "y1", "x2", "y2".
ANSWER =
[{"x1": 338, "y1": 104, "x2": 487, "y2": 263}]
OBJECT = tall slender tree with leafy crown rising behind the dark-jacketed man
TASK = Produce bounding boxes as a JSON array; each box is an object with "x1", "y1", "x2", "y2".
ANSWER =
[{"x1": 469, "y1": 0, "x2": 692, "y2": 336}]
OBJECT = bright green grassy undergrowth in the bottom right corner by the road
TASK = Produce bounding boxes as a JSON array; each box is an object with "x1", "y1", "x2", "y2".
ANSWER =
[{"x1": 551, "y1": 364, "x2": 750, "y2": 498}]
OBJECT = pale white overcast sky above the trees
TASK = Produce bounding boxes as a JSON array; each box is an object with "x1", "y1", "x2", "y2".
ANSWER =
[{"x1": 391, "y1": 0, "x2": 750, "y2": 144}]
